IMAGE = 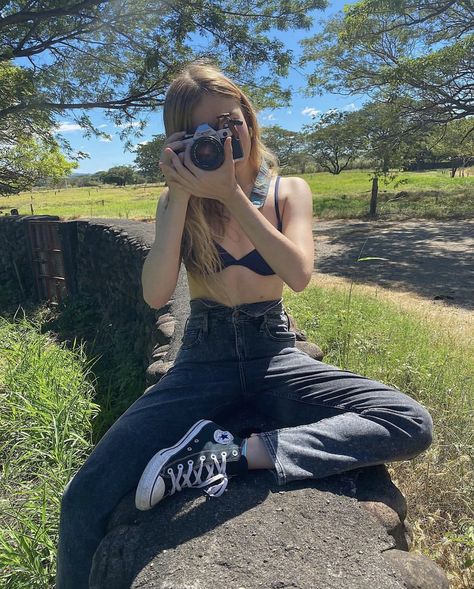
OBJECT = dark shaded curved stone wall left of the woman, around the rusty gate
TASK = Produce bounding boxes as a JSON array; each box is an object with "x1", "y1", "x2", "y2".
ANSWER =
[{"x1": 0, "y1": 215, "x2": 178, "y2": 372}]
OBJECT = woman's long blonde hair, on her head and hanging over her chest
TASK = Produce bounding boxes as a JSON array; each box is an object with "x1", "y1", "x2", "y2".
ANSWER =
[{"x1": 163, "y1": 59, "x2": 278, "y2": 301}]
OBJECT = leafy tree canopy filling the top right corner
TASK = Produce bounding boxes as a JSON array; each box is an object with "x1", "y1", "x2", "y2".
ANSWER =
[{"x1": 301, "y1": 0, "x2": 474, "y2": 125}]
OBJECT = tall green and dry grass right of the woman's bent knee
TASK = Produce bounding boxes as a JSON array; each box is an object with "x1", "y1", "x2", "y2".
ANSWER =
[{"x1": 285, "y1": 282, "x2": 474, "y2": 589}]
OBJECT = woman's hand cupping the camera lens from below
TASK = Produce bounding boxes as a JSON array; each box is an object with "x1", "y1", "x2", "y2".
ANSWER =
[{"x1": 160, "y1": 137, "x2": 238, "y2": 204}]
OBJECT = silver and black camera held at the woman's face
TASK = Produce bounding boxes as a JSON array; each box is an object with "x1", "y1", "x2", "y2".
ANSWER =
[{"x1": 182, "y1": 113, "x2": 244, "y2": 170}]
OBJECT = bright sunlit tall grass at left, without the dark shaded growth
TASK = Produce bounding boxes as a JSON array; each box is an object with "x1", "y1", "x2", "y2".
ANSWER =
[{"x1": 0, "y1": 316, "x2": 99, "y2": 589}]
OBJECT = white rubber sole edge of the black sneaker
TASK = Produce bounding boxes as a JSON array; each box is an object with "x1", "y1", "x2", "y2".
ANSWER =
[{"x1": 135, "y1": 419, "x2": 212, "y2": 511}]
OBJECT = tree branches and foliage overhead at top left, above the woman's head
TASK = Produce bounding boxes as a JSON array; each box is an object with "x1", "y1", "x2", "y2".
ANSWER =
[{"x1": 0, "y1": 0, "x2": 327, "y2": 147}]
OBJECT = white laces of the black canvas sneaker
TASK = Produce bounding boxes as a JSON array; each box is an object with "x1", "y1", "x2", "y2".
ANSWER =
[{"x1": 168, "y1": 452, "x2": 229, "y2": 497}]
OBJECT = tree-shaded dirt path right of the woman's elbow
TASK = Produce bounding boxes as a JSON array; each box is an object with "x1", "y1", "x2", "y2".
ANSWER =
[{"x1": 313, "y1": 219, "x2": 474, "y2": 311}]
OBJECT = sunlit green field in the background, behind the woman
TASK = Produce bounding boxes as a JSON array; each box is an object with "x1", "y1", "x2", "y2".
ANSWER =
[{"x1": 0, "y1": 168, "x2": 474, "y2": 219}]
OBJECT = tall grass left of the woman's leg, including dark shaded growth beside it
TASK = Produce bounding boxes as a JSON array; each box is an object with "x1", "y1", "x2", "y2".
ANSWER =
[{"x1": 0, "y1": 300, "x2": 145, "y2": 589}]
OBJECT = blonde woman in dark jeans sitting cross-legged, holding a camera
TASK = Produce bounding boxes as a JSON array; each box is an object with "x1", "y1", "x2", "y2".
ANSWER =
[{"x1": 56, "y1": 62, "x2": 432, "y2": 589}]
